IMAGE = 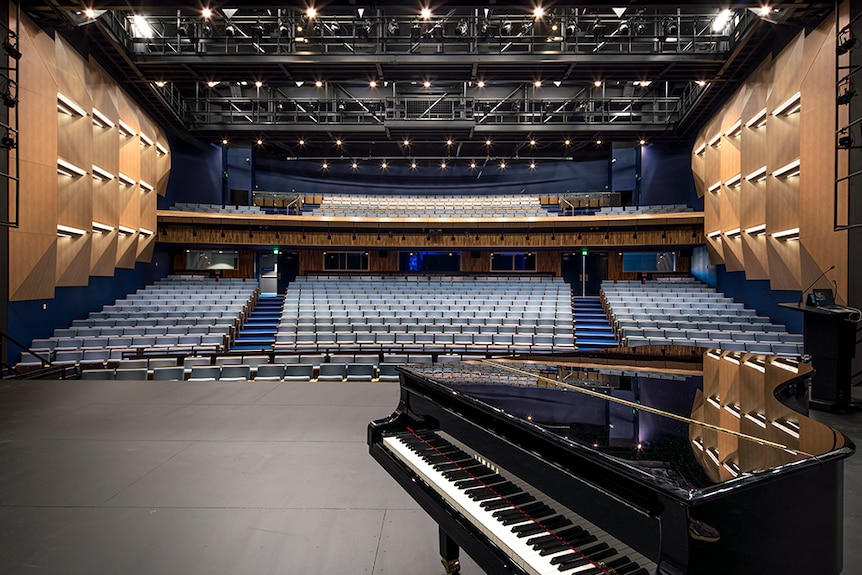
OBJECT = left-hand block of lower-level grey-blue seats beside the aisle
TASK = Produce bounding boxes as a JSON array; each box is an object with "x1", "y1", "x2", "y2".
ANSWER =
[{"x1": 18, "y1": 275, "x2": 257, "y2": 374}]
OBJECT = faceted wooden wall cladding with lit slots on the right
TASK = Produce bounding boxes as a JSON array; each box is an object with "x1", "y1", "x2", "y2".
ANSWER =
[{"x1": 692, "y1": 12, "x2": 847, "y2": 298}]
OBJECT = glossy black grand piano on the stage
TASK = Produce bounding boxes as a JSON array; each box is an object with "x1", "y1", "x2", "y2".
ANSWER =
[{"x1": 368, "y1": 346, "x2": 854, "y2": 575}]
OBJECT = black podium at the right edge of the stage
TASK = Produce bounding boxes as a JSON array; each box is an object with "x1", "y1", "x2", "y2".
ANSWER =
[{"x1": 778, "y1": 303, "x2": 856, "y2": 411}]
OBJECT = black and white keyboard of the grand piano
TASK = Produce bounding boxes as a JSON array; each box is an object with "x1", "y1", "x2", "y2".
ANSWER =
[{"x1": 383, "y1": 431, "x2": 655, "y2": 575}]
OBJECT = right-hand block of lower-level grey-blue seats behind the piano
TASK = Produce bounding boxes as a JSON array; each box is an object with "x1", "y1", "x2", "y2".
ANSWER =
[{"x1": 602, "y1": 278, "x2": 803, "y2": 356}]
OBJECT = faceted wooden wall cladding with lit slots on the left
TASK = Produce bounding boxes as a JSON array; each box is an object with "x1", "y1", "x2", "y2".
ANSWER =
[{"x1": 9, "y1": 11, "x2": 170, "y2": 300}]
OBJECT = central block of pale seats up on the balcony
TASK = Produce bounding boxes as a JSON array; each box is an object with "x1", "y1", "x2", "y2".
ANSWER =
[{"x1": 306, "y1": 194, "x2": 552, "y2": 218}]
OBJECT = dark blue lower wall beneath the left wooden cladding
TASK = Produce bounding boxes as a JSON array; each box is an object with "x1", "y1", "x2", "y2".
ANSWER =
[{"x1": 9, "y1": 245, "x2": 171, "y2": 362}]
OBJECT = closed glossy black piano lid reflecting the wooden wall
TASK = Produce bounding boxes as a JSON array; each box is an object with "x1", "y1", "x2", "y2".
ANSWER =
[{"x1": 402, "y1": 346, "x2": 854, "y2": 499}]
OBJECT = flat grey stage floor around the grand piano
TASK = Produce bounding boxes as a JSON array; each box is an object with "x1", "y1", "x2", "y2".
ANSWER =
[{"x1": 0, "y1": 381, "x2": 862, "y2": 575}]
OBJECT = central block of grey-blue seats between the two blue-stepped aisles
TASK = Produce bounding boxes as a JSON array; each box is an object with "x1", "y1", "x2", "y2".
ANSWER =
[{"x1": 275, "y1": 275, "x2": 574, "y2": 356}]
